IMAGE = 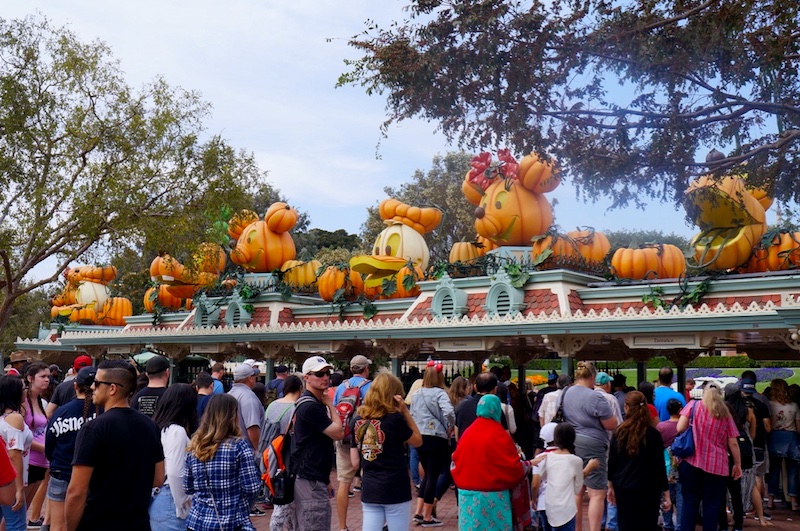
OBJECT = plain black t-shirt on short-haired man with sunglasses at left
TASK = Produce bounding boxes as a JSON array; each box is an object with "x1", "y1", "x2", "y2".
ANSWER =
[{"x1": 72, "y1": 408, "x2": 164, "y2": 531}]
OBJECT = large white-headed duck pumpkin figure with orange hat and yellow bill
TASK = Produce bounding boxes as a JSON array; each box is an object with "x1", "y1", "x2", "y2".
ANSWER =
[{"x1": 350, "y1": 199, "x2": 442, "y2": 297}]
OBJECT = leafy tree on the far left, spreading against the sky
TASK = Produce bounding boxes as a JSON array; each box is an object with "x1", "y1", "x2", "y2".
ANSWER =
[{"x1": 0, "y1": 17, "x2": 262, "y2": 330}]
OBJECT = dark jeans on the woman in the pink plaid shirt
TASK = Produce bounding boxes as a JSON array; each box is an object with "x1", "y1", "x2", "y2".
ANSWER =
[{"x1": 678, "y1": 461, "x2": 726, "y2": 531}]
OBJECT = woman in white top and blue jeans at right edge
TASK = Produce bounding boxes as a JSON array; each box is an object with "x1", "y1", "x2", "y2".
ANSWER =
[{"x1": 767, "y1": 378, "x2": 800, "y2": 511}]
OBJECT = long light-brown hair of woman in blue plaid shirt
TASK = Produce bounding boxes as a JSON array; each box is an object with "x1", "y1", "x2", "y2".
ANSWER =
[{"x1": 187, "y1": 394, "x2": 242, "y2": 463}]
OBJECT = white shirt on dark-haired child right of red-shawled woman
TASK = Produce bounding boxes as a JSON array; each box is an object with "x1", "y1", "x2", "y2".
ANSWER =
[{"x1": 540, "y1": 454, "x2": 583, "y2": 527}]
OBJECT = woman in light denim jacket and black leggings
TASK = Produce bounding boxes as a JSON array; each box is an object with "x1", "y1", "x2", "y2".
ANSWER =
[{"x1": 411, "y1": 362, "x2": 455, "y2": 527}]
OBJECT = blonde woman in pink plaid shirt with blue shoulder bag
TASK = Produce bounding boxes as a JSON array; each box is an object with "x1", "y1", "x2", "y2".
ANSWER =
[{"x1": 678, "y1": 382, "x2": 742, "y2": 531}]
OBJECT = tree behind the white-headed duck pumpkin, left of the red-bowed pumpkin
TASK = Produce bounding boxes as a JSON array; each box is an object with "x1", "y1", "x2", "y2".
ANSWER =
[{"x1": 361, "y1": 152, "x2": 475, "y2": 261}]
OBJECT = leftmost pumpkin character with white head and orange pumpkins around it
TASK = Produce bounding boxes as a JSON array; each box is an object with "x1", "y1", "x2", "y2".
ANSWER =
[{"x1": 50, "y1": 266, "x2": 133, "y2": 326}]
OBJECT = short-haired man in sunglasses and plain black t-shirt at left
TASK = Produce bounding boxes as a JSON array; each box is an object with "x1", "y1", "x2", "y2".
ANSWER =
[{"x1": 65, "y1": 360, "x2": 164, "y2": 531}]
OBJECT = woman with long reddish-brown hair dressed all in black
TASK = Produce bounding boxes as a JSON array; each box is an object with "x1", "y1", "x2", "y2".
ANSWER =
[{"x1": 608, "y1": 391, "x2": 672, "y2": 531}]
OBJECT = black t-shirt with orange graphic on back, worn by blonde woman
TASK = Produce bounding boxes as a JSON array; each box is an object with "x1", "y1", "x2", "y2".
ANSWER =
[{"x1": 353, "y1": 413, "x2": 414, "y2": 504}]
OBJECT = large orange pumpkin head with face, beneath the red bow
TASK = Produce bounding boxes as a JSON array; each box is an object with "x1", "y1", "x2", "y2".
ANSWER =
[{"x1": 475, "y1": 179, "x2": 553, "y2": 245}]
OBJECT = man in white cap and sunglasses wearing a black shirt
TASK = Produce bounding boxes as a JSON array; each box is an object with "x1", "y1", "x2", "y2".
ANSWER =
[{"x1": 291, "y1": 356, "x2": 344, "y2": 531}]
